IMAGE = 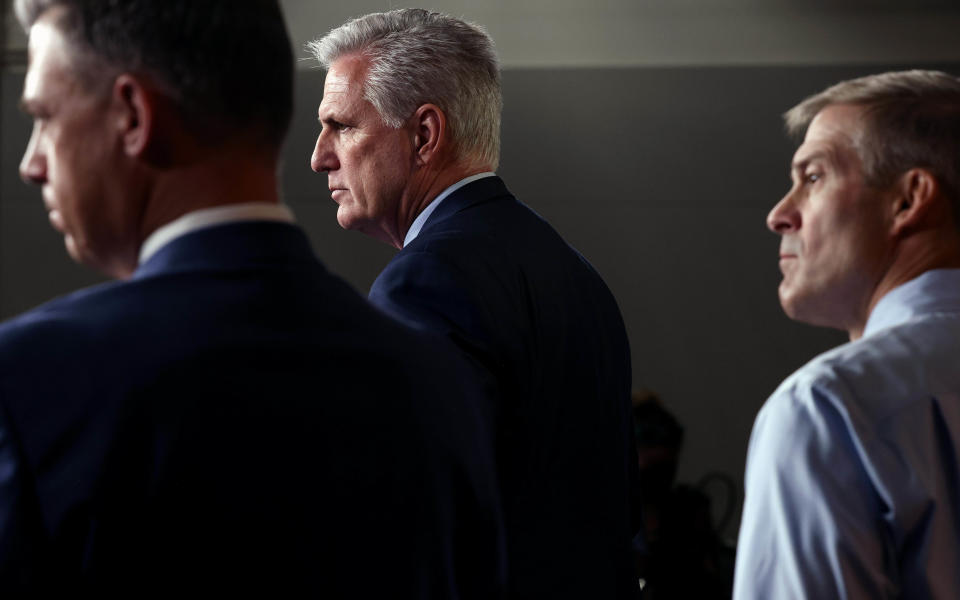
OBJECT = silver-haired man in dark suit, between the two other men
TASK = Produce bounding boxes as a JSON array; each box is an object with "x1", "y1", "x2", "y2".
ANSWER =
[{"x1": 310, "y1": 9, "x2": 639, "y2": 599}]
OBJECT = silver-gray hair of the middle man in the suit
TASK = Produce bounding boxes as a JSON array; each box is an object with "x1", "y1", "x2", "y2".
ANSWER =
[{"x1": 307, "y1": 8, "x2": 503, "y2": 169}]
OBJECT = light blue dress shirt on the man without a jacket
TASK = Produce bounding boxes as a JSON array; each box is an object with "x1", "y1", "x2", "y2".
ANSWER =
[{"x1": 734, "y1": 269, "x2": 960, "y2": 600}]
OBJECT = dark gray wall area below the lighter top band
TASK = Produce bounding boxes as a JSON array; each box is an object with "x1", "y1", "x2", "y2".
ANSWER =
[{"x1": 7, "y1": 64, "x2": 960, "y2": 535}]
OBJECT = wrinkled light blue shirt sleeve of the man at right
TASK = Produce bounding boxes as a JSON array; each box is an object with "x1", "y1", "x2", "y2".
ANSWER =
[{"x1": 734, "y1": 380, "x2": 897, "y2": 600}]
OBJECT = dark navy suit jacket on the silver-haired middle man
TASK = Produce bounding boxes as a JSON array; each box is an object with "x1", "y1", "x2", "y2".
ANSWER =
[{"x1": 370, "y1": 177, "x2": 640, "y2": 600}]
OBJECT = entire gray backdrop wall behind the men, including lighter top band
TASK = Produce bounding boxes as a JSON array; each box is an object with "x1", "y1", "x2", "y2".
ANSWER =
[{"x1": 0, "y1": 0, "x2": 960, "y2": 536}]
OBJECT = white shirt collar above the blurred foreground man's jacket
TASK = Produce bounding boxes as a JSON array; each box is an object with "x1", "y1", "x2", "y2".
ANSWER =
[{"x1": 140, "y1": 202, "x2": 293, "y2": 265}]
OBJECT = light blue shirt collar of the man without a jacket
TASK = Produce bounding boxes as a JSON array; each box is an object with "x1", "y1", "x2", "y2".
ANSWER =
[{"x1": 863, "y1": 269, "x2": 960, "y2": 337}]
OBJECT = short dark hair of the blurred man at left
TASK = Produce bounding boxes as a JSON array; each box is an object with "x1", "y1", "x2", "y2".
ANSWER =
[{"x1": 15, "y1": 0, "x2": 293, "y2": 149}]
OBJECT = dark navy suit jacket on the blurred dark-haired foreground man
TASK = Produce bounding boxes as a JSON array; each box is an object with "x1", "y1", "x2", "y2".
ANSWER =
[{"x1": 0, "y1": 222, "x2": 503, "y2": 600}]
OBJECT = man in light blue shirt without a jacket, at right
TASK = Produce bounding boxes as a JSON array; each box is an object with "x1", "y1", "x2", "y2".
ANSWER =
[{"x1": 734, "y1": 71, "x2": 960, "y2": 599}]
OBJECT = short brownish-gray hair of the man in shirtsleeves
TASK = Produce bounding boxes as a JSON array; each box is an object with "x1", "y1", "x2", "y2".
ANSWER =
[{"x1": 783, "y1": 70, "x2": 960, "y2": 216}]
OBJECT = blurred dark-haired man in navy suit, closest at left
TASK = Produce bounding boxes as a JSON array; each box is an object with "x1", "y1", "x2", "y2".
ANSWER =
[{"x1": 0, "y1": 0, "x2": 503, "y2": 600}]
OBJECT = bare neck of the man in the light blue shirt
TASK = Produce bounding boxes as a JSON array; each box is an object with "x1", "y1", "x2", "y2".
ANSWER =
[{"x1": 847, "y1": 225, "x2": 960, "y2": 340}]
